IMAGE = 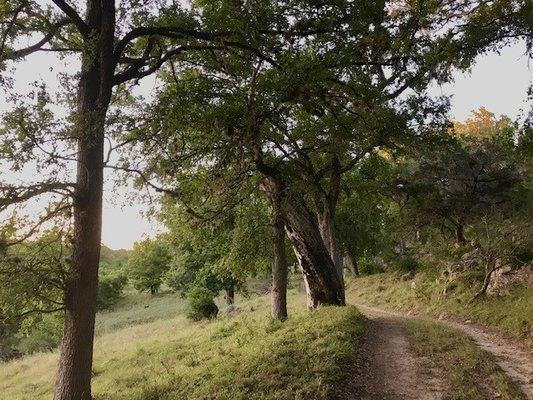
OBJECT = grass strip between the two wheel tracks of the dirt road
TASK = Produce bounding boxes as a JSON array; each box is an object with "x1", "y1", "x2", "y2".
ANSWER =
[{"x1": 406, "y1": 319, "x2": 526, "y2": 400}]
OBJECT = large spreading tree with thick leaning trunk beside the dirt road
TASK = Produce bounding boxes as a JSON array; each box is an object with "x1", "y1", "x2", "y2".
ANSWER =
[{"x1": 121, "y1": 1, "x2": 529, "y2": 308}]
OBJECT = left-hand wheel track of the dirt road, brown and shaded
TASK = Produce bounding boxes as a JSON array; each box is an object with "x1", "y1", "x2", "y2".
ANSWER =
[{"x1": 339, "y1": 312, "x2": 445, "y2": 400}]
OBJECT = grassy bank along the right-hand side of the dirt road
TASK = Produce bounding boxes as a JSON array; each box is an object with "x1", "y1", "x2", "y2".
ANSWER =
[{"x1": 347, "y1": 272, "x2": 533, "y2": 345}]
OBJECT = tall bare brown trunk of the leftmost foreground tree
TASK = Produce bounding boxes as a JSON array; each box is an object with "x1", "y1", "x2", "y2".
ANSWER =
[{"x1": 54, "y1": 0, "x2": 115, "y2": 400}]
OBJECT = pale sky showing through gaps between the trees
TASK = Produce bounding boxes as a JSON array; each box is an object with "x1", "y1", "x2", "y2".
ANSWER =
[{"x1": 0, "y1": 44, "x2": 533, "y2": 249}]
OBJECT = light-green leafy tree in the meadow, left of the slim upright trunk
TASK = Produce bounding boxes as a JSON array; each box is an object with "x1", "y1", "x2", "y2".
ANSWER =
[{"x1": 162, "y1": 197, "x2": 272, "y2": 304}]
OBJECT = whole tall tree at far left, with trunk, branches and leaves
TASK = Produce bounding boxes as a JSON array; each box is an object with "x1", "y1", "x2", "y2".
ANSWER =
[{"x1": 0, "y1": 0, "x2": 274, "y2": 400}]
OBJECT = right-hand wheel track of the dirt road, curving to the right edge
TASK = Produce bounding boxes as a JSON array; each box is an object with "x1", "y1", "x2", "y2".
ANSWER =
[{"x1": 355, "y1": 304, "x2": 533, "y2": 400}]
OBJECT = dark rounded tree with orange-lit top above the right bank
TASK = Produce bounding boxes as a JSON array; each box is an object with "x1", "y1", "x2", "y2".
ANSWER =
[{"x1": 395, "y1": 109, "x2": 521, "y2": 244}]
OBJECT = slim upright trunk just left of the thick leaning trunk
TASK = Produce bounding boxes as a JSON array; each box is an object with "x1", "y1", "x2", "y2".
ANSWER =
[{"x1": 271, "y1": 189, "x2": 289, "y2": 321}]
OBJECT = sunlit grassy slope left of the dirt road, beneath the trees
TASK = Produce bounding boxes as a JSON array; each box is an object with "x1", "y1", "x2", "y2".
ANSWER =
[{"x1": 0, "y1": 290, "x2": 364, "y2": 400}]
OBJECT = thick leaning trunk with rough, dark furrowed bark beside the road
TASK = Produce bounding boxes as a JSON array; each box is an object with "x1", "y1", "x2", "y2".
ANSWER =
[{"x1": 263, "y1": 177, "x2": 346, "y2": 309}]
